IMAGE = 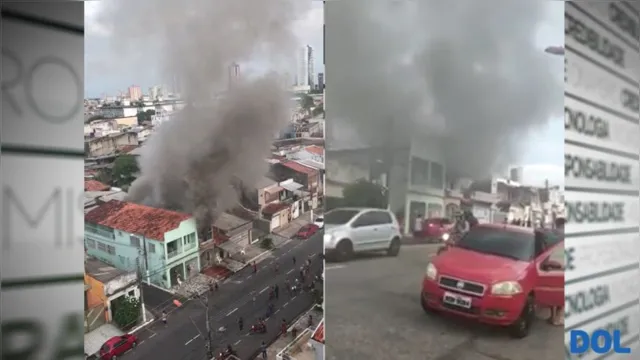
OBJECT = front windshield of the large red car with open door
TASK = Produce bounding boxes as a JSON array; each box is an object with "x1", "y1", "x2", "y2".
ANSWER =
[{"x1": 456, "y1": 227, "x2": 535, "y2": 261}]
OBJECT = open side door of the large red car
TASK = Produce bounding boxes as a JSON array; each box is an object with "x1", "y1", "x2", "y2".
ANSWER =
[{"x1": 534, "y1": 241, "x2": 565, "y2": 307}]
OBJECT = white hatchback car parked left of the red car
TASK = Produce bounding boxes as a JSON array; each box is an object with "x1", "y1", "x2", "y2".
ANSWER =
[{"x1": 324, "y1": 208, "x2": 402, "y2": 261}]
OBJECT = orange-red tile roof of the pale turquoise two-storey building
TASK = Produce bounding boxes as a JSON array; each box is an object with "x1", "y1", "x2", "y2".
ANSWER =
[{"x1": 84, "y1": 200, "x2": 191, "y2": 241}]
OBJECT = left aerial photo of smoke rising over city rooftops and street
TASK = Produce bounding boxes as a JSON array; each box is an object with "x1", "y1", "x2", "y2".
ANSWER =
[{"x1": 84, "y1": 0, "x2": 325, "y2": 360}]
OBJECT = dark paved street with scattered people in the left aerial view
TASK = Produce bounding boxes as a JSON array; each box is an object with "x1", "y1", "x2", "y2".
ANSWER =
[{"x1": 123, "y1": 234, "x2": 322, "y2": 360}]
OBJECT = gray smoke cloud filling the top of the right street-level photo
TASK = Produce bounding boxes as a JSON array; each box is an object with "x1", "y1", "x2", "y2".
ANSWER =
[{"x1": 325, "y1": 0, "x2": 563, "y2": 177}]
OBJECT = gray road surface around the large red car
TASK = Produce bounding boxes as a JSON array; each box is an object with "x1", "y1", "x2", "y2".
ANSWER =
[{"x1": 325, "y1": 245, "x2": 564, "y2": 360}]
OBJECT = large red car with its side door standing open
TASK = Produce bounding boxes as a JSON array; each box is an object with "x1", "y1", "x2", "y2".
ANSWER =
[{"x1": 420, "y1": 224, "x2": 564, "y2": 338}]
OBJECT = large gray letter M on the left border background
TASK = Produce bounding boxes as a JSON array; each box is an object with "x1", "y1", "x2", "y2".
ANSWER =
[{"x1": 2, "y1": 186, "x2": 63, "y2": 249}]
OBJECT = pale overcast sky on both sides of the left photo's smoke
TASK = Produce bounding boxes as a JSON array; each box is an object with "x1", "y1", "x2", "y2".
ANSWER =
[{"x1": 85, "y1": 1, "x2": 324, "y2": 97}]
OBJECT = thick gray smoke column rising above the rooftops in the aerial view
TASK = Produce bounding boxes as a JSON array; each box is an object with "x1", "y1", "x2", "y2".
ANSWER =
[{"x1": 98, "y1": 0, "x2": 305, "y2": 229}]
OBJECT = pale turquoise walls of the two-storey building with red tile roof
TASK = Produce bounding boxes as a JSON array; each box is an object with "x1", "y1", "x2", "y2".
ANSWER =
[{"x1": 85, "y1": 219, "x2": 200, "y2": 289}]
